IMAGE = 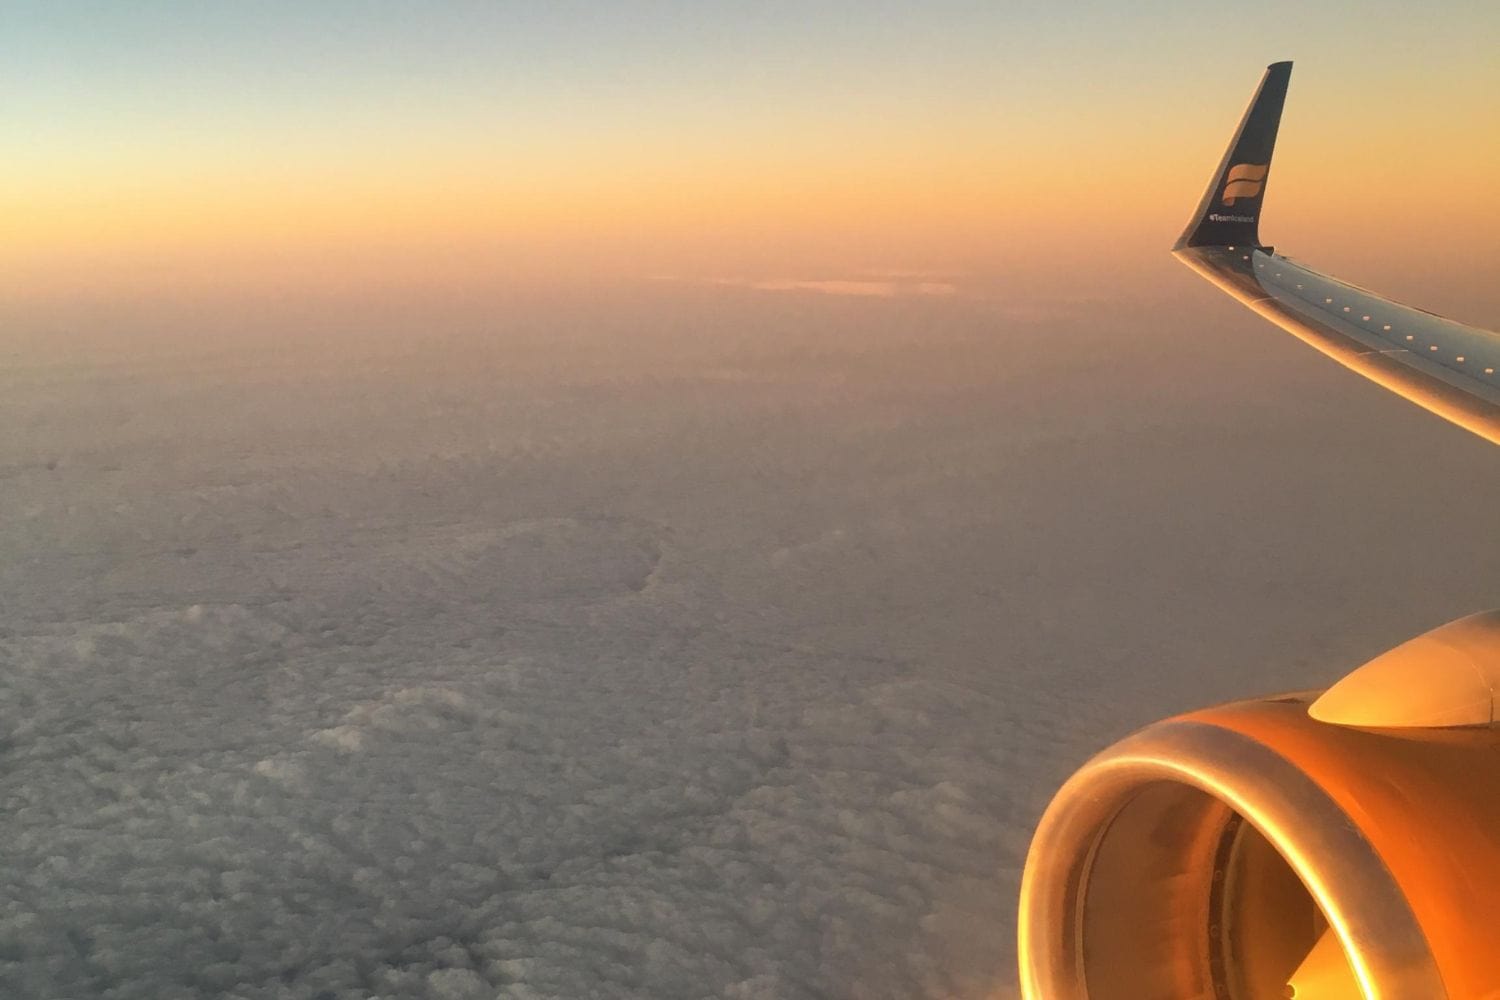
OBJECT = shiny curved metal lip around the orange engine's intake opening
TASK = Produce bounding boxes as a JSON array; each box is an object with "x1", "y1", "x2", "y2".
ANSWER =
[{"x1": 1017, "y1": 720, "x2": 1448, "y2": 1000}]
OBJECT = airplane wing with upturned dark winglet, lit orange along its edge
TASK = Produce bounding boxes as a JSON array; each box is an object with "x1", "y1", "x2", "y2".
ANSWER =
[{"x1": 1172, "y1": 63, "x2": 1500, "y2": 444}]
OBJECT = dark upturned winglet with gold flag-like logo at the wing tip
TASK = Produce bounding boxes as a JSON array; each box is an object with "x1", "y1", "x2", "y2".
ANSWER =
[{"x1": 1172, "y1": 63, "x2": 1292, "y2": 250}]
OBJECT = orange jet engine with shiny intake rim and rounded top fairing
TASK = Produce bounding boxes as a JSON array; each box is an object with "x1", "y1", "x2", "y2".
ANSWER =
[{"x1": 1019, "y1": 612, "x2": 1500, "y2": 1000}]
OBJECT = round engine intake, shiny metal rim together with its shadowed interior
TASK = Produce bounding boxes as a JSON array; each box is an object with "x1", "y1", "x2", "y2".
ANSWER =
[{"x1": 1020, "y1": 700, "x2": 1448, "y2": 1000}]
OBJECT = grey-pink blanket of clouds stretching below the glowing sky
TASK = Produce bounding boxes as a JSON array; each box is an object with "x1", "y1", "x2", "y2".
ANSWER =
[{"x1": 0, "y1": 289, "x2": 1500, "y2": 1000}]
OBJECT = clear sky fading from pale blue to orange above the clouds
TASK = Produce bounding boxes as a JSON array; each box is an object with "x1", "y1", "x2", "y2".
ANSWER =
[{"x1": 0, "y1": 0, "x2": 1500, "y2": 315}]
